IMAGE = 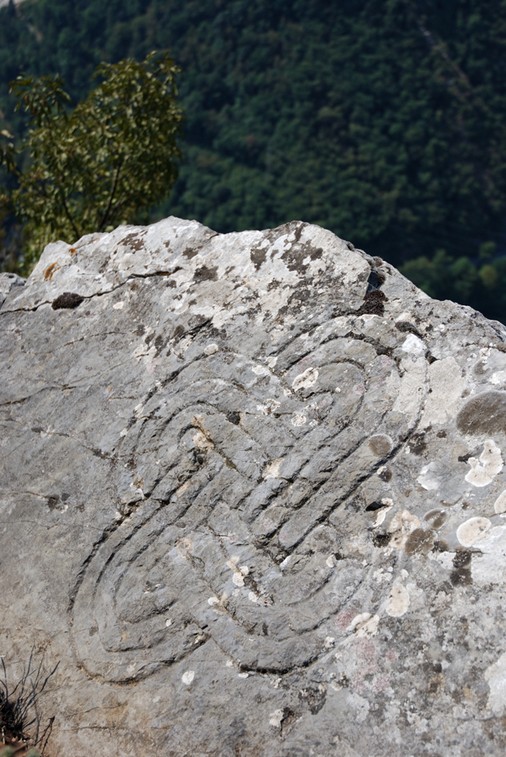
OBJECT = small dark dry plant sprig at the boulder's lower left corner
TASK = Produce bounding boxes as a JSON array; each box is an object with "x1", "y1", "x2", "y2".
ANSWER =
[{"x1": 0, "y1": 650, "x2": 59, "y2": 757}]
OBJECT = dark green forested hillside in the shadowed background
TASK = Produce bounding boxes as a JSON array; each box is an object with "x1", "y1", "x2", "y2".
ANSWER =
[{"x1": 0, "y1": 0, "x2": 506, "y2": 320}]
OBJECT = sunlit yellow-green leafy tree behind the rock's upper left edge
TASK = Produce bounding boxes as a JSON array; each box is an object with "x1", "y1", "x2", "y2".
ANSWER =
[{"x1": 0, "y1": 52, "x2": 182, "y2": 270}]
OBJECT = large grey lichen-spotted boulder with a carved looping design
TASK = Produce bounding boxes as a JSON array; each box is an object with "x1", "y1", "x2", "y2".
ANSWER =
[{"x1": 0, "y1": 218, "x2": 506, "y2": 757}]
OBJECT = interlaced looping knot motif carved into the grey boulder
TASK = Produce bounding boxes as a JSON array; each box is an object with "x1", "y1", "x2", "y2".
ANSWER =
[{"x1": 70, "y1": 324, "x2": 427, "y2": 682}]
